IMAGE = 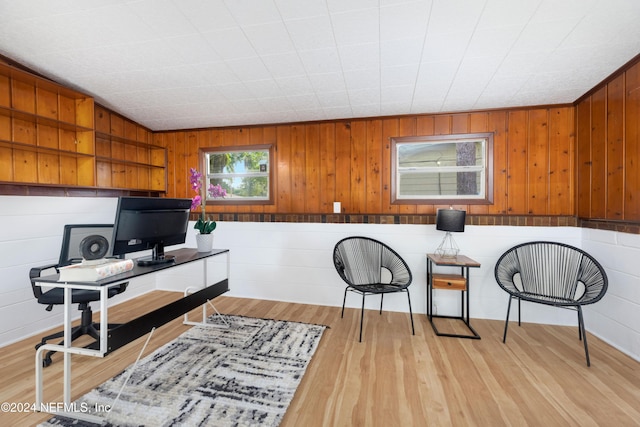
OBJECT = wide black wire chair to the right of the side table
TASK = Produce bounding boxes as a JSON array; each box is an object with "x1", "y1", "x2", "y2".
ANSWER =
[{"x1": 495, "y1": 242, "x2": 608, "y2": 366}]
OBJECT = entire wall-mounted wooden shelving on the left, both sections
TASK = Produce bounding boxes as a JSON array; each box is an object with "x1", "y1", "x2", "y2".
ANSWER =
[{"x1": 0, "y1": 63, "x2": 167, "y2": 193}]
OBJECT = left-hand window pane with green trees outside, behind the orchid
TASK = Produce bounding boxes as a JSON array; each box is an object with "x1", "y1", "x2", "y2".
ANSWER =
[{"x1": 203, "y1": 145, "x2": 273, "y2": 204}]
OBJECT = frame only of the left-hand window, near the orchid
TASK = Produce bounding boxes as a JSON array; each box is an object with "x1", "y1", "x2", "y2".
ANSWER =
[{"x1": 199, "y1": 144, "x2": 276, "y2": 205}]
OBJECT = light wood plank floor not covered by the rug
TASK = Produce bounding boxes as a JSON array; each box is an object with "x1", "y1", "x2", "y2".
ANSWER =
[{"x1": 0, "y1": 291, "x2": 640, "y2": 427}]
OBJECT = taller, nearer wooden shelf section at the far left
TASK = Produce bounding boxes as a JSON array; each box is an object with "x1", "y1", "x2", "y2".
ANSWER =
[{"x1": 0, "y1": 63, "x2": 95, "y2": 186}]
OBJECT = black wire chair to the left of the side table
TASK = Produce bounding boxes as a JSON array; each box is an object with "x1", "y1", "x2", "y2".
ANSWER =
[{"x1": 333, "y1": 236, "x2": 416, "y2": 342}]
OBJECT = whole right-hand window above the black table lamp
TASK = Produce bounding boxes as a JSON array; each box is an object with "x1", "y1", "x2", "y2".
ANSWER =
[{"x1": 391, "y1": 133, "x2": 493, "y2": 204}]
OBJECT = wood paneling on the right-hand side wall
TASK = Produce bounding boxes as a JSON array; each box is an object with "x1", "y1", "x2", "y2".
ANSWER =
[{"x1": 576, "y1": 61, "x2": 640, "y2": 222}]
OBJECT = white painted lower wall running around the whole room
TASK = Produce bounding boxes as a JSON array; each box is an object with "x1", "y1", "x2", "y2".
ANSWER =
[{"x1": 0, "y1": 196, "x2": 640, "y2": 360}]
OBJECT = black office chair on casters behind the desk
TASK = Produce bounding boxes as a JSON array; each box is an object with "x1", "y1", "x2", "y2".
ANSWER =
[{"x1": 29, "y1": 224, "x2": 128, "y2": 367}]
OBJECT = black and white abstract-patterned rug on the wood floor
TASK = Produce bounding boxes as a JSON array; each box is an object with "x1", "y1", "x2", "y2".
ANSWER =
[{"x1": 40, "y1": 316, "x2": 326, "y2": 427}]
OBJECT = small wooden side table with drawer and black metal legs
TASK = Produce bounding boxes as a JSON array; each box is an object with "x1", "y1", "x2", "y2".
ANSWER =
[{"x1": 427, "y1": 254, "x2": 480, "y2": 340}]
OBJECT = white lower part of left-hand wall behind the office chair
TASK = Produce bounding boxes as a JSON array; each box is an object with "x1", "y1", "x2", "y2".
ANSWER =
[{"x1": 0, "y1": 196, "x2": 155, "y2": 346}]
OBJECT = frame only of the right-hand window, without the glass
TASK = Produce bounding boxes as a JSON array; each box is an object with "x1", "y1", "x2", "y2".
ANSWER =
[{"x1": 390, "y1": 132, "x2": 493, "y2": 205}]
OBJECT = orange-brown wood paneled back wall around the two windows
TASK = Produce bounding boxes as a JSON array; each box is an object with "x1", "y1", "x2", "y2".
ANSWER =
[{"x1": 153, "y1": 106, "x2": 576, "y2": 216}]
